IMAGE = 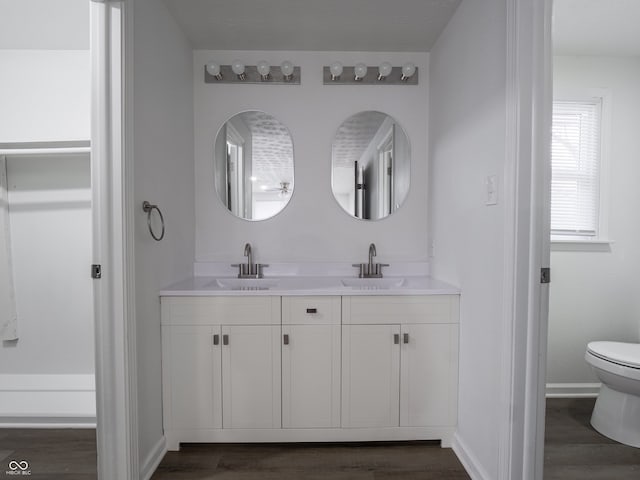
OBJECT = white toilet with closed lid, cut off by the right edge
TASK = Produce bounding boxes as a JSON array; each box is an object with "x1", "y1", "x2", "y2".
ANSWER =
[{"x1": 585, "y1": 342, "x2": 640, "y2": 448}]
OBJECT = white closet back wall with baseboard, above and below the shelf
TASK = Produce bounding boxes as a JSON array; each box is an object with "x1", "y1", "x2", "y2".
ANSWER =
[{"x1": 0, "y1": 48, "x2": 95, "y2": 423}]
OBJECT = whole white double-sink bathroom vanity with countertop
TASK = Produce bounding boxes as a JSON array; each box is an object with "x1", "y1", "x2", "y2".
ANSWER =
[{"x1": 161, "y1": 277, "x2": 459, "y2": 450}]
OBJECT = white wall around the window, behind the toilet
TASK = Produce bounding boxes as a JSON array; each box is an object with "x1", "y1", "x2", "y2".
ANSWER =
[{"x1": 547, "y1": 56, "x2": 640, "y2": 383}]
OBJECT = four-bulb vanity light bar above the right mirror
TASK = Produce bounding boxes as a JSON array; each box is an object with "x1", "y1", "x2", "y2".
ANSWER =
[{"x1": 322, "y1": 62, "x2": 418, "y2": 85}]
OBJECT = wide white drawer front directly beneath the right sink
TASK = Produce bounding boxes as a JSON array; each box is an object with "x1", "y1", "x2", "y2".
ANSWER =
[{"x1": 342, "y1": 295, "x2": 459, "y2": 324}]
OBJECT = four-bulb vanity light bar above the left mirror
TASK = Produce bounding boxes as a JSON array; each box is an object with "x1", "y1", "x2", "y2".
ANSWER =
[{"x1": 204, "y1": 61, "x2": 300, "y2": 85}]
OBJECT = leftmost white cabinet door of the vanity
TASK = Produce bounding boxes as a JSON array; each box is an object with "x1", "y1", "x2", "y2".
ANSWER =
[{"x1": 162, "y1": 326, "x2": 222, "y2": 429}]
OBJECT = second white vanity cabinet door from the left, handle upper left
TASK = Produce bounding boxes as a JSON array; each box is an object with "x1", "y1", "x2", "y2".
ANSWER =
[{"x1": 222, "y1": 325, "x2": 281, "y2": 428}]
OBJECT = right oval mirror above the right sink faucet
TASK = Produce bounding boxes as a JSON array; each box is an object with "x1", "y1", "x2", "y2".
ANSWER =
[{"x1": 331, "y1": 111, "x2": 411, "y2": 220}]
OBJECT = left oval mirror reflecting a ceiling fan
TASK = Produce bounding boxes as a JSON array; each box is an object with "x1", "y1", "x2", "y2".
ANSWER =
[{"x1": 214, "y1": 111, "x2": 294, "y2": 220}]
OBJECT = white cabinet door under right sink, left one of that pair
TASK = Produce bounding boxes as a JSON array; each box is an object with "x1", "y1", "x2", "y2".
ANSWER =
[{"x1": 342, "y1": 325, "x2": 400, "y2": 427}]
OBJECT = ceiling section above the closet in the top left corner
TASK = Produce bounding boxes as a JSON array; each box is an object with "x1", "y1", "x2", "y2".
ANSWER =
[{"x1": 0, "y1": 0, "x2": 91, "y2": 50}]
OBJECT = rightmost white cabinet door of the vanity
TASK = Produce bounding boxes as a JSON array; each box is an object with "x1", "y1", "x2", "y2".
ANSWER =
[{"x1": 400, "y1": 324, "x2": 458, "y2": 426}]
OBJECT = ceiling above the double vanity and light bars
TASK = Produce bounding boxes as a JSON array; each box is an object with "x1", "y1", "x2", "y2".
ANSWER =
[{"x1": 160, "y1": 0, "x2": 461, "y2": 52}]
